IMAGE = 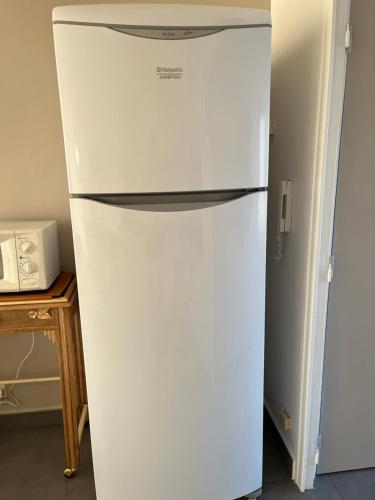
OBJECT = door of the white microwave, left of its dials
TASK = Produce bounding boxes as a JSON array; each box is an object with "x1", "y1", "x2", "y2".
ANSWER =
[{"x1": 0, "y1": 232, "x2": 20, "y2": 292}]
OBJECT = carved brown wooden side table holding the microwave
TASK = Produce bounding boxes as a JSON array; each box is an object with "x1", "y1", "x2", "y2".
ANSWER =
[{"x1": 0, "y1": 273, "x2": 88, "y2": 477}]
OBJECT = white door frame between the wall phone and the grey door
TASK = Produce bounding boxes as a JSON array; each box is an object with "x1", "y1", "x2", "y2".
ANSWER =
[{"x1": 294, "y1": 0, "x2": 351, "y2": 491}]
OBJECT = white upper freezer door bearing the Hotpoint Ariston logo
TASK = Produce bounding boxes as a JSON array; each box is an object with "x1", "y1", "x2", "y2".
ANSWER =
[{"x1": 54, "y1": 24, "x2": 271, "y2": 194}]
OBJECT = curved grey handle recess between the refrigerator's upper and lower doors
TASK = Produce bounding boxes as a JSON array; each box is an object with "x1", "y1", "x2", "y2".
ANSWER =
[{"x1": 71, "y1": 188, "x2": 266, "y2": 212}]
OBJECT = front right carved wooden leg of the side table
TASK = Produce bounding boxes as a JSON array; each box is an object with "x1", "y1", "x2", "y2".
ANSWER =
[{"x1": 58, "y1": 308, "x2": 79, "y2": 477}]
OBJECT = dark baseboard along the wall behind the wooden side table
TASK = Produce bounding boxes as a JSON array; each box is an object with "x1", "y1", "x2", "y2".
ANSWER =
[{"x1": 0, "y1": 408, "x2": 63, "y2": 429}]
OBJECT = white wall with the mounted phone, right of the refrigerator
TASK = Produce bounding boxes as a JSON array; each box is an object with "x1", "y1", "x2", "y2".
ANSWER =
[{"x1": 265, "y1": 0, "x2": 332, "y2": 464}]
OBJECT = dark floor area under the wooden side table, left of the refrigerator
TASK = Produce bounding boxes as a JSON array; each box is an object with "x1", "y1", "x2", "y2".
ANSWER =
[{"x1": 0, "y1": 425, "x2": 96, "y2": 500}]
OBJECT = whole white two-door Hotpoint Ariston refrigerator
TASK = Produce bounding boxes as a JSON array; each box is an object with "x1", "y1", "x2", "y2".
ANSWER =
[{"x1": 53, "y1": 4, "x2": 271, "y2": 500}]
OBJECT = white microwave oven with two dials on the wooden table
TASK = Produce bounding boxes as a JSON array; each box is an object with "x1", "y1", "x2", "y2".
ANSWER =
[{"x1": 0, "y1": 220, "x2": 60, "y2": 293}]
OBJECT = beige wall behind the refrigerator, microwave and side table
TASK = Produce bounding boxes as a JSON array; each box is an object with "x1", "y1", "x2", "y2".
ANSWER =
[{"x1": 0, "y1": 0, "x2": 270, "y2": 413}]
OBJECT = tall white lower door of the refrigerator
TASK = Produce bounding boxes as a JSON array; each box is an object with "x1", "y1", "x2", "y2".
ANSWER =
[{"x1": 71, "y1": 192, "x2": 267, "y2": 500}]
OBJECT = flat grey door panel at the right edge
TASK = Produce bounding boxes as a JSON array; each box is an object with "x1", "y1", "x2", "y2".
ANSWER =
[{"x1": 318, "y1": 0, "x2": 375, "y2": 472}]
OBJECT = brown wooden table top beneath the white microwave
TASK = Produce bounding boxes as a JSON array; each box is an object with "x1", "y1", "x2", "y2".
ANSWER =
[{"x1": 0, "y1": 272, "x2": 77, "y2": 309}]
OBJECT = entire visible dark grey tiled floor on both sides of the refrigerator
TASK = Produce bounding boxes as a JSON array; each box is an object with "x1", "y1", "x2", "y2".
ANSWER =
[{"x1": 0, "y1": 425, "x2": 375, "y2": 500}]
